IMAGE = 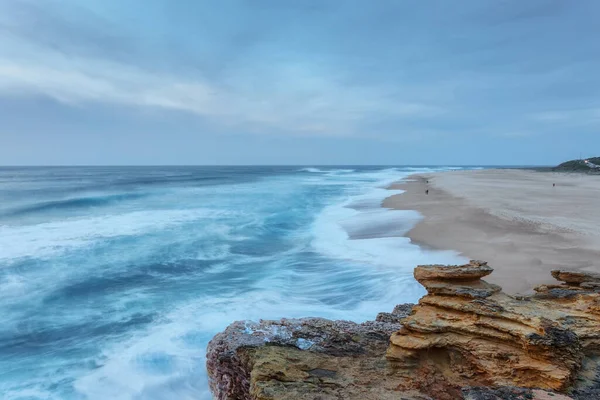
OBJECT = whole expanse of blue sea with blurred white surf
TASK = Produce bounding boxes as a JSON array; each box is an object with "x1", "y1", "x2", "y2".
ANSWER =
[{"x1": 0, "y1": 167, "x2": 462, "y2": 400}]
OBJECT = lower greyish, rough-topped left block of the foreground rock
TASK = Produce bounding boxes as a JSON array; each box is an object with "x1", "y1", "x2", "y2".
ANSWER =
[{"x1": 207, "y1": 305, "x2": 430, "y2": 400}]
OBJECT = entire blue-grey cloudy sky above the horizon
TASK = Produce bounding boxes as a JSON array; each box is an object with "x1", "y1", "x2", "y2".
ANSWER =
[{"x1": 0, "y1": 0, "x2": 600, "y2": 165}]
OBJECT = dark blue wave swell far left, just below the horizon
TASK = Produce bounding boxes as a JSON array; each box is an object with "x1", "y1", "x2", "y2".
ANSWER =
[{"x1": 9, "y1": 193, "x2": 150, "y2": 216}]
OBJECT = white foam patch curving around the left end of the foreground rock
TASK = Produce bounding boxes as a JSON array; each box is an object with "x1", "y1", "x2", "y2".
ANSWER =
[{"x1": 74, "y1": 290, "x2": 336, "y2": 400}]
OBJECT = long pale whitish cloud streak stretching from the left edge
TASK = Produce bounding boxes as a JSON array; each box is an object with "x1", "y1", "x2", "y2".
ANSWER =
[{"x1": 0, "y1": 44, "x2": 442, "y2": 135}]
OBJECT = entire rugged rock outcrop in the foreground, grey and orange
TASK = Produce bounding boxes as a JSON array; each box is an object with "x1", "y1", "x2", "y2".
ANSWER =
[{"x1": 207, "y1": 261, "x2": 600, "y2": 400}]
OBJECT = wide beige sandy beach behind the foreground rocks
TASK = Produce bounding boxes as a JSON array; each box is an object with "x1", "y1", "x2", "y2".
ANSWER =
[{"x1": 383, "y1": 169, "x2": 600, "y2": 294}]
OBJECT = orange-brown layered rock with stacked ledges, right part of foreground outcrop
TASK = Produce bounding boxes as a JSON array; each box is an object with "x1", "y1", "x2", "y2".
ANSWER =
[{"x1": 387, "y1": 261, "x2": 600, "y2": 399}]
